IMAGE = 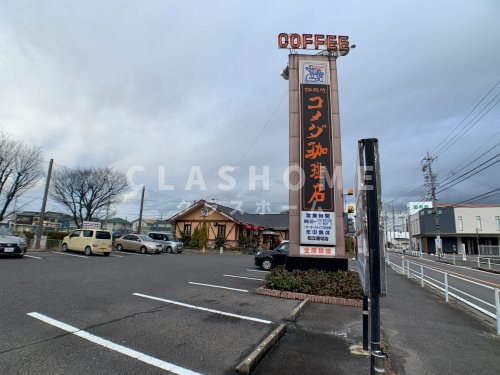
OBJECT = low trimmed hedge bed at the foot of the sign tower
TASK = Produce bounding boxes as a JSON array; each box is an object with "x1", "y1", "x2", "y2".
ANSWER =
[{"x1": 264, "y1": 266, "x2": 363, "y2": 299}]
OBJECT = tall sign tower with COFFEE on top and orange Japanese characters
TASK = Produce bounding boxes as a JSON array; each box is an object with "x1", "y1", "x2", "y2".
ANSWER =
[{"x1": 278, "y1": 33, "x2": 354, "y2": 270}]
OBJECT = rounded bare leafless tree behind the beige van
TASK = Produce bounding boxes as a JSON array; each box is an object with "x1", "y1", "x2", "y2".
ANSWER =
[{"x1": 50, "y1": 168, "x2": 129, "y2": 226}]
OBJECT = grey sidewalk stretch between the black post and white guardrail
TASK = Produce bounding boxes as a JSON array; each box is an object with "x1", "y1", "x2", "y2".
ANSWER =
[{"x1": 380, "y1": 268, "x2": 500, "y2": 375}]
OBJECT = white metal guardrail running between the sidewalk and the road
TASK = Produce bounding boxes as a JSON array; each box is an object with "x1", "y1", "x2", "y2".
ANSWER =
[{"x1": 385, "y1": 254, "x2": 500, "y2": 335}]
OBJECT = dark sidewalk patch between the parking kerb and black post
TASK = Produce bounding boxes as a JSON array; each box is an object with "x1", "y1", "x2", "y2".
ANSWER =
[{"x1": 252, "y1": 303, "x2": 370, "y2": 375}]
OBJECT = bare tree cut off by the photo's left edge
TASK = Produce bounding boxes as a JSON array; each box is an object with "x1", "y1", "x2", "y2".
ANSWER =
[{"x1": 0, "y1": 132, "x2": 43, "y2": 220}]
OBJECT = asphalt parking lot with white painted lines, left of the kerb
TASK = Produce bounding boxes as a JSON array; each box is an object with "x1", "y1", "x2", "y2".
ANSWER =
[{"x1": 0, "y1": 251, "x2": 299, "y2": 374}]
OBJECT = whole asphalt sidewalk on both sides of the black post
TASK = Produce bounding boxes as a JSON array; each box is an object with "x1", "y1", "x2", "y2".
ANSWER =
[{"x1": 253, "y1": 262, "x2": 500, "y2": 375}]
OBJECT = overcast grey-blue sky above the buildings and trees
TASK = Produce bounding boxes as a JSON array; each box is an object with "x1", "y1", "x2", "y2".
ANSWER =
[{"x1": 0, "y1": 0, "x2": 500, "y2": 220}]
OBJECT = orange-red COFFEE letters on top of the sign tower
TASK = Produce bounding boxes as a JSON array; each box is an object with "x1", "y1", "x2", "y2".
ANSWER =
[{"x1": 278, "y1": 33, "x2": 349, "y2": 51}]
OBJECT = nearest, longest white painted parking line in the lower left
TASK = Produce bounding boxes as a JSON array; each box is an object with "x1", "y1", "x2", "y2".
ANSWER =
[{"x1": 28, "y1": 312, "x2": 201, "y2": 375}]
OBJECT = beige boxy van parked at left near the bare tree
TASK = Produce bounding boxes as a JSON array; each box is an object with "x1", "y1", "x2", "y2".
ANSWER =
[{"x1": 61, "y1": 229, "x2": 113, "y2": 256}]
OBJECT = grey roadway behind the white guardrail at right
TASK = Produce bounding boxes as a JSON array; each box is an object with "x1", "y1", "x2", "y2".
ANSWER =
[{"x1": 389, "y1": 253, "x2": 500, "y2": 319}]
